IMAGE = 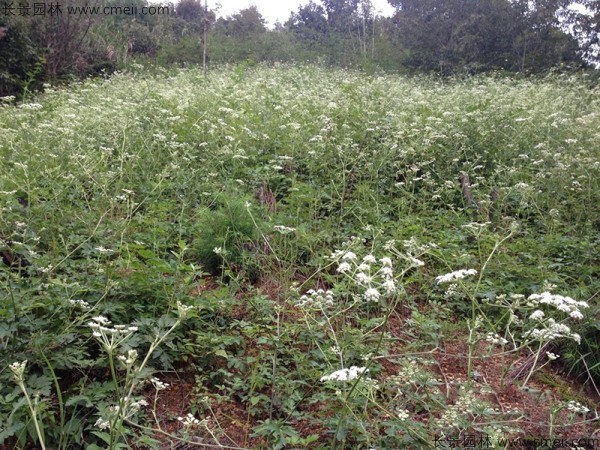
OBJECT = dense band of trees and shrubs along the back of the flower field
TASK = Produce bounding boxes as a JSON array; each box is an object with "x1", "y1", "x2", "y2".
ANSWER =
[{"x1": 0, "y1": 0, "x2": 600, "y2": 96}]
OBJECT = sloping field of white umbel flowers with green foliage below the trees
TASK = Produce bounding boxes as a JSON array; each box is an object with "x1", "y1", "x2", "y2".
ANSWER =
[{"x1": 0, "y1": 65, "x2": 600, "y2": 450}]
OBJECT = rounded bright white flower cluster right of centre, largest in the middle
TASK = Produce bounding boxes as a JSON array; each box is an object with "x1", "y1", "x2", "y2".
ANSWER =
[{"x1": 331, "y1": 251, "x2": 398, "y2": 303}]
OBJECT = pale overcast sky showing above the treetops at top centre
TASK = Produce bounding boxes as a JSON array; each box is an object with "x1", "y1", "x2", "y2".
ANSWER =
[{"x1": 208, "y1": 0, "x2": 393, "y2": 27}]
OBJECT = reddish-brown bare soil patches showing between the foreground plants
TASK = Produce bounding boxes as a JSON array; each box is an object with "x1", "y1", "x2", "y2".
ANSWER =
[{"x1": 0, "y1": 279, "x2": 600, "y2": 450}]
